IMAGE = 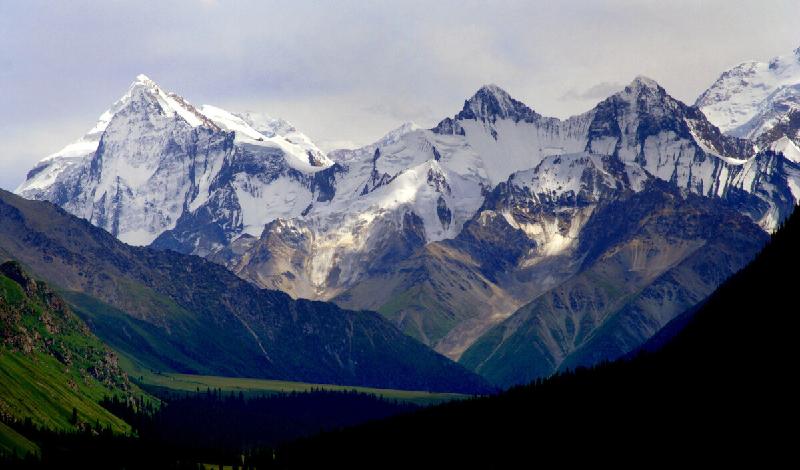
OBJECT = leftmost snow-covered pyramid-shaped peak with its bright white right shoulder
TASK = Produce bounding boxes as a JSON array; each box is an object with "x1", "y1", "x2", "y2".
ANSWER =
[{"x1": 16, "y1": 74, "x2": 333, "y2": 245}]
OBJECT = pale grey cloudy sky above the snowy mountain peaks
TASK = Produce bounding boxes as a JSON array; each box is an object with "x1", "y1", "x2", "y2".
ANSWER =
[{"x1": 0, "y1": 0, "x2": 800, "y2": 190}]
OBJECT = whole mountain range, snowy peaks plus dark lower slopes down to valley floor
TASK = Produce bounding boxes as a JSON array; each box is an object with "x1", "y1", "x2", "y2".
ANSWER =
[{"x1": 14, "y1": 45, "x2": 800, "y2": 392}]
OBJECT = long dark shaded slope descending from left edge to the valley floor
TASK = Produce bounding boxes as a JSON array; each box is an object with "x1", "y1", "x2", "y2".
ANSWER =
[{"x1": 0, "y1": 192, "x2": 487, "y2": 392}]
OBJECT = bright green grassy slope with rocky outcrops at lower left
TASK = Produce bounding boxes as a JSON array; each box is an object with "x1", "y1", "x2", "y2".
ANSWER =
[{"x1": 0, "y1": 266, "x2": 130, "y2": 432}]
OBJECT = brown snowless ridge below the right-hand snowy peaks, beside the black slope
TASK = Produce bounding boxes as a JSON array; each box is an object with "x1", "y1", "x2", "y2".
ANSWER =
[{"x1": 461, "y1": 183, "x2": 767, "y2": 386}]
